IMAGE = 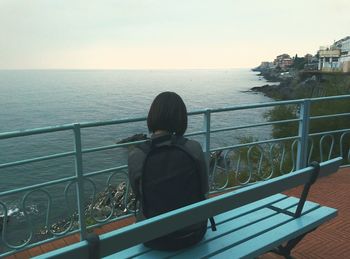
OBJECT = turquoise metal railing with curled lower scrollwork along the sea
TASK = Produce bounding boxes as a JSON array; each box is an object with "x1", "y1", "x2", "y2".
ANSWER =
[{"x1": 0, "y1": 95, "x2": 350, "y2": 256}]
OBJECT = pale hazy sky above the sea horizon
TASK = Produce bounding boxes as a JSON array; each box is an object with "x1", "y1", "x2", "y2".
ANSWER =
[{"x1": 0, "y1": 0, "x2": 350, "y2": 69}]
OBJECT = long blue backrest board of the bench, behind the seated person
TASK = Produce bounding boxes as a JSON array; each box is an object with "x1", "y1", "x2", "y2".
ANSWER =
[{"x1": 33, "y1": 157, "x2": 342, "y2": 259}]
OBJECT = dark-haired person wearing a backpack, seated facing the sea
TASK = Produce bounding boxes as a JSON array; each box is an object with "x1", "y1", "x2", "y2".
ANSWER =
[{"x1": 128, "y1": 92, "x2": 209, "y2": 250}]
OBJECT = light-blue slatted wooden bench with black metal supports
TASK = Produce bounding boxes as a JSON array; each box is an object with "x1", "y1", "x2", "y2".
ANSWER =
[{"x1": 36, "y1": 158, "x2": 342, "y2": 259}]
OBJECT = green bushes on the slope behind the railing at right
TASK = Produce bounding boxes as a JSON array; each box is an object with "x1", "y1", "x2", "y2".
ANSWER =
[{"x1": 213, "y1": 74, "x2": 350, "y2": 188}]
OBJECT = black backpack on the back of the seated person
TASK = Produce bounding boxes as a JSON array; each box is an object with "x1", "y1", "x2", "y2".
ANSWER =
[{"x1": 136, "y1": 135, "x2": 216, "y2": 240}]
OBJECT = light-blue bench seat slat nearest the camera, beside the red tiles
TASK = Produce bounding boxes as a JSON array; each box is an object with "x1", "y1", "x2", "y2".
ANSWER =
[{"x1": 213, "y1": 207, "x2": 337, "y2": 258}]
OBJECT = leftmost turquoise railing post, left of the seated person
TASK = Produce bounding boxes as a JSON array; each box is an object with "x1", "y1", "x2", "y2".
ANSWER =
[{"x1": 74, "y1": 124, "x2": 87, "y2": 240}]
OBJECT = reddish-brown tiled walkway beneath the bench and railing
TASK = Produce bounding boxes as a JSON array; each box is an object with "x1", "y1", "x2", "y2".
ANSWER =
[{"x1": 7, "y1": 168, "x2": 350, "y2": 259}]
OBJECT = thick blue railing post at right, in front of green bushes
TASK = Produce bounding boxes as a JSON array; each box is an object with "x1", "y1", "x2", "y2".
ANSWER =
[{"x1": 297, "y1": 99, "x2": 310, "y2": 170}]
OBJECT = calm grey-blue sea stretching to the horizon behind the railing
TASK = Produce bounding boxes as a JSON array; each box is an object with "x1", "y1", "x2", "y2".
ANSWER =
[{"x1": 0, "y1": 69, "x2": 271, "y2": 228}]
